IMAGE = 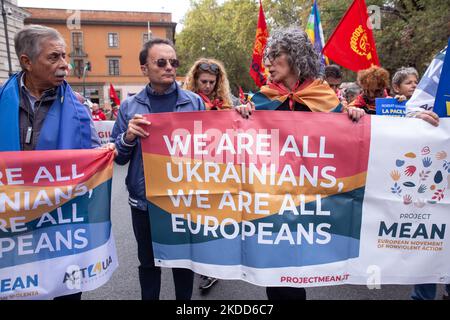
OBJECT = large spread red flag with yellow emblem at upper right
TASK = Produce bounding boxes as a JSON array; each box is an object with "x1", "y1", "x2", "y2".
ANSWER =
[{"x1": 322, "y1": 0, "x2": 380, "y2": 72}]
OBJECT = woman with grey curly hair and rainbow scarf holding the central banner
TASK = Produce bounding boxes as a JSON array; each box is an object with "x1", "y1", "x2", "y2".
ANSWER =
[{"x1": 236, "y1": 27, "x2": 364, "y2": 121}]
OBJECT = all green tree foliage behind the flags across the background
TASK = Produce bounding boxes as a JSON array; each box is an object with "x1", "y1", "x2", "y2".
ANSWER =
[{"x1": 176, "y1": 0, "x2": 450, "y2": 92}]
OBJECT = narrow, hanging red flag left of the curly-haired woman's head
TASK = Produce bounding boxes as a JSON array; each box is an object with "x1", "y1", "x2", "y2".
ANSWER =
[{"x1": 250, "y1": 0, "x2": 269, "y2": 87}]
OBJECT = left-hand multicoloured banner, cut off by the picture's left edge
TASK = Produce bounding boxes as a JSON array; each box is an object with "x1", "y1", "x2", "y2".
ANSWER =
[{"x1": 0, "y1": 150, "x2": 118, "y2": 300}]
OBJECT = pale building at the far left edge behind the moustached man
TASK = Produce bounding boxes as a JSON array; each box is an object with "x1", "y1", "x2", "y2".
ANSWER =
[{"x1": 0, "y1": 0, "x2": 30, "y2": 85}]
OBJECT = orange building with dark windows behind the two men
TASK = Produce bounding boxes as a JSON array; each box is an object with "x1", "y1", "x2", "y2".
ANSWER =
[{"x1": 25, "y1": 8, "x2": 176, "y2": 105}]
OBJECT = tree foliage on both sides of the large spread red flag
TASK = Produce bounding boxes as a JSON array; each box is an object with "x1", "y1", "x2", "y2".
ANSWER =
[{"x1": 319, "y1": 0, "x2": 450, "y2": 74}]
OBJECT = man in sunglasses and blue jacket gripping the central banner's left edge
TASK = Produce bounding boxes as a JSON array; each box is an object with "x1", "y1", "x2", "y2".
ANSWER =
[{"x1": 111, "y1": 38, "x2": 205, "y2": 300}]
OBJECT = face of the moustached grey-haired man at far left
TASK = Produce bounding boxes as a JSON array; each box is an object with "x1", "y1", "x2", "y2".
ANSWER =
[{"x1": 22, "y1": 39, "x2": 69, "y2": 89}]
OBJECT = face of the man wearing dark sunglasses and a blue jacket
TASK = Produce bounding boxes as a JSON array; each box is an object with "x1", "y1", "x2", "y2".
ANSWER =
[{"x1": 141, "y1": 44, "x2": 177, "y2": 86}]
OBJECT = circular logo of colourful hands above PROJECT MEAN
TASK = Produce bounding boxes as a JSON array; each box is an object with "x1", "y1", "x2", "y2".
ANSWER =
[{"x1": 389, "y1": 146, "x2": 450, "y2": 208}]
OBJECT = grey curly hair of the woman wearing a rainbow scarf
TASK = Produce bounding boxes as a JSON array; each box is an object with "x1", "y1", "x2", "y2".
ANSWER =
[{"x1": 264, "y1": 27, "x2": 320, "y2": 81}]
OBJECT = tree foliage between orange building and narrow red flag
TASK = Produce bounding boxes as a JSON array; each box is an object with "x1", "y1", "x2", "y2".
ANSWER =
[{"x1": 176, "y1": 0, "x2": 258, "y2": 92}]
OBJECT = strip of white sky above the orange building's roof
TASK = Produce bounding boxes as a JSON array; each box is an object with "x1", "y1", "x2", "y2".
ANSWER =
[{"x1": 18, "y1": 0, "x2": 189, "y2": 31}]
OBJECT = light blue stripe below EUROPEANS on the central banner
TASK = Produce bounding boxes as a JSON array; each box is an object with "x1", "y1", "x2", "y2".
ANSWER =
[{"x1": 153, "y1": 233, "x2": 359, "y2": 268}]
